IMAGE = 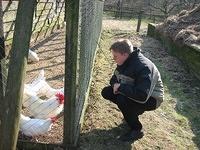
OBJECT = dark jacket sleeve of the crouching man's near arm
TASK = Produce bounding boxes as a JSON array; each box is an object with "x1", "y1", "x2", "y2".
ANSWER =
[{"x1": 118, "y1": 67, "x2": 151, "y2": 103}]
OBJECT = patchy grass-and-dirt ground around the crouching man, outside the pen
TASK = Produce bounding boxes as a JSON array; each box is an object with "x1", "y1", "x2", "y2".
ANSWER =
[{"x1": 79, "y1": 20, "x2": 199, "y2": 150}]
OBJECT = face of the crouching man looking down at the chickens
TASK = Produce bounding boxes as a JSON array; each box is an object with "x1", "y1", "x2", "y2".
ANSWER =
[{"x1": 111, "y1": 50, "x2": 129, "y2": 66}]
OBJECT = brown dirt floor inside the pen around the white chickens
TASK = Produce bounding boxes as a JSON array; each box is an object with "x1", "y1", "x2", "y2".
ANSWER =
[{"x1": 19, "y1": 31, "x2": 65, "y2": 144}]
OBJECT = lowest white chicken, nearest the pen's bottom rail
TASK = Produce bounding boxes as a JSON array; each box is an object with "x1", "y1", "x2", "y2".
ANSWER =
[{"x1": 19, "y1": 114, "x2": 57, "y2": 137}]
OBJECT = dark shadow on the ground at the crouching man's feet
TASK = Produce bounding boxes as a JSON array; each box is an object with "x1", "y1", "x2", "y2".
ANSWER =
[{"x1": 78, "y1": 123, "x2": 137, "y2": 150}]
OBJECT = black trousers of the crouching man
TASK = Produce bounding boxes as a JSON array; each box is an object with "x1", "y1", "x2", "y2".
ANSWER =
[{"x1": 101, "y1": 86, "x2": 156, "y2": 130}]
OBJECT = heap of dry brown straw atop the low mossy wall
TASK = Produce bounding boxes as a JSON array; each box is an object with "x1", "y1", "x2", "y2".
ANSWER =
[{"x1": 156, "y1": 5, "x2": 200, "y2": 45}]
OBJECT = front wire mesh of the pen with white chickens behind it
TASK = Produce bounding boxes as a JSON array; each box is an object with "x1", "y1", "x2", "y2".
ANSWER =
[{"x1": 0, "y1": 0, "x2": 64, "y2": 143}]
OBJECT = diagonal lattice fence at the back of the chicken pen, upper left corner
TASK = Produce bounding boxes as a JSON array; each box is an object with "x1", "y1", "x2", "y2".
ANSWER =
[{"x1": 2, "y1": 0, "x2": 64, "y2": 53}]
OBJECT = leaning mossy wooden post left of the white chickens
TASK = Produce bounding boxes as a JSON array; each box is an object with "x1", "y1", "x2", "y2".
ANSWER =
[{"x1": 0, "y1": 0, "x2": 36, "y2": 150}]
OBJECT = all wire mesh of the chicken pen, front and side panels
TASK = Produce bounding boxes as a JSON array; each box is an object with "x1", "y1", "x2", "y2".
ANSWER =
[{"x1": 0, "y1": 0, "x2": 103, "y2": 148}]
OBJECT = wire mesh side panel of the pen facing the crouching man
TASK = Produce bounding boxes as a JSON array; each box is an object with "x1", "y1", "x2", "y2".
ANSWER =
[{"x1": 75, "y1": 0, "x2": 103, "y2": 134}]
